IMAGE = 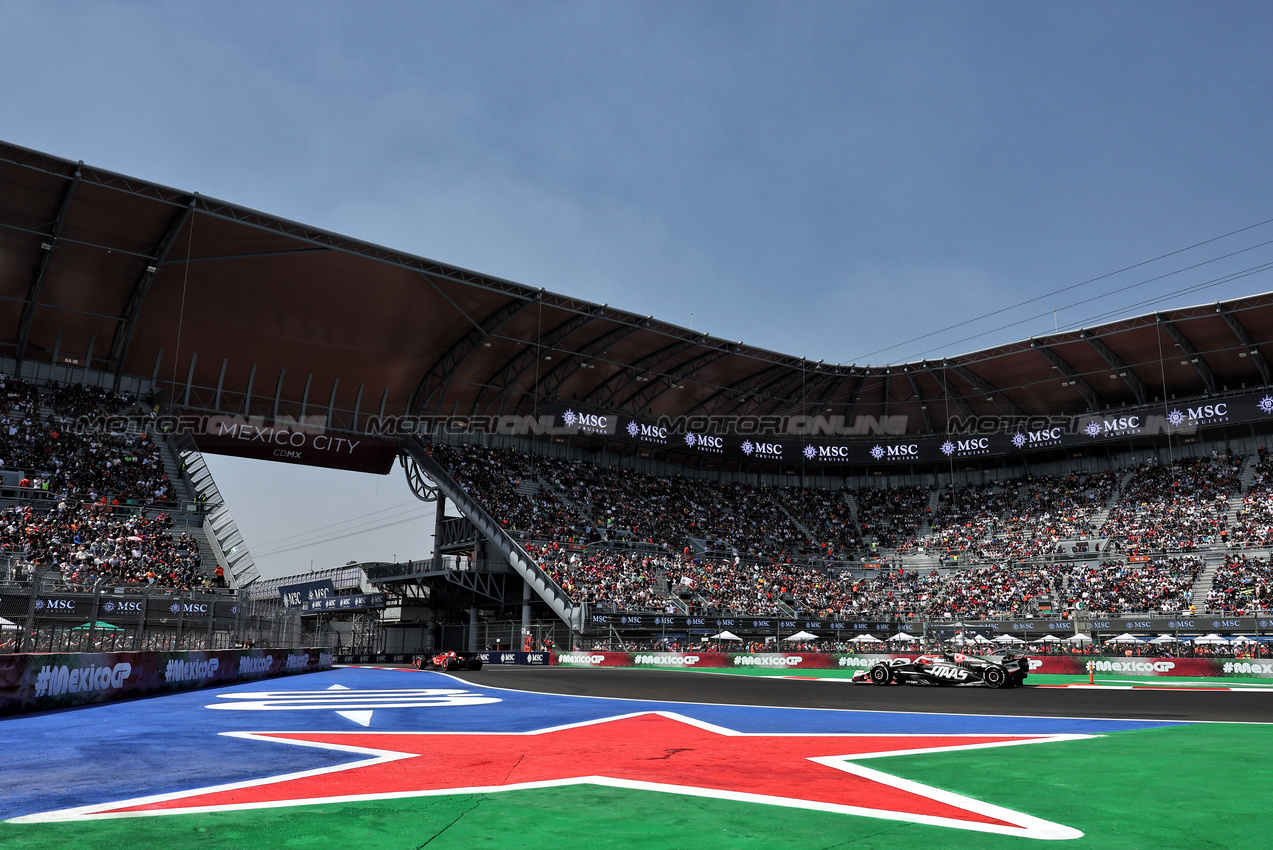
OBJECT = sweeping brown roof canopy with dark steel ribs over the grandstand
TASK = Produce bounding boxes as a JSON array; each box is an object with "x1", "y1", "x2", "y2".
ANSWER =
[{"x1": 0, "y1": 143, "x2": 1273, "y2": 434}]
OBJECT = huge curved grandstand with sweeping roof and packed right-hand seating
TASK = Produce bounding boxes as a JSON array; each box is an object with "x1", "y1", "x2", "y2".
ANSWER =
[{"x1": 0, "y1": 143, "x2": 1273, "y2": 649}]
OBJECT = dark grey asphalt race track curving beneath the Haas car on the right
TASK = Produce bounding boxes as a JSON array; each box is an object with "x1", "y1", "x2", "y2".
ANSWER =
[{"x1": 443, "y1": 665, "x2": 1273, "y2": 723}]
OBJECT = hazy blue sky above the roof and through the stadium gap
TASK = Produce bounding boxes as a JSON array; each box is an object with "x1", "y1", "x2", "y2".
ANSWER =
[{"x1": 0, "y1": 0, "x2": 1273, "y2": 574}]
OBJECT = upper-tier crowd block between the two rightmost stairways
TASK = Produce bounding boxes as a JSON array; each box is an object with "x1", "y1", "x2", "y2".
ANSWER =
[{"x1": 1100, "y1": 454, "x2": 1242, "y2": 551}]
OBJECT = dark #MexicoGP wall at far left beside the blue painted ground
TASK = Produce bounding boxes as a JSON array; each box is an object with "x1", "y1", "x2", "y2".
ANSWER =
[{"x1": 0, "y1": 649, "x2": 332, "y2": 715}]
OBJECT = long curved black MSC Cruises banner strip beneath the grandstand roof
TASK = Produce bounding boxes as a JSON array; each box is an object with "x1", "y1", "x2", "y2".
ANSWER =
[{"x1": 540, "y1": 392, "x2": 1273, "y2": 466}]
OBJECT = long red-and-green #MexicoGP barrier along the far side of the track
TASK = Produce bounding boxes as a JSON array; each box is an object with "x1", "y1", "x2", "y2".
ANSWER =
[{"x1": 552, "y1": 649, "x2": 1273, "y2": 678}]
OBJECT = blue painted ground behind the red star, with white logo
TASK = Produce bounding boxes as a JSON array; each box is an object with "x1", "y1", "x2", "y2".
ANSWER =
[{"x1": 0, "y1": 668, "x2": 1179, "y2": 819}]
